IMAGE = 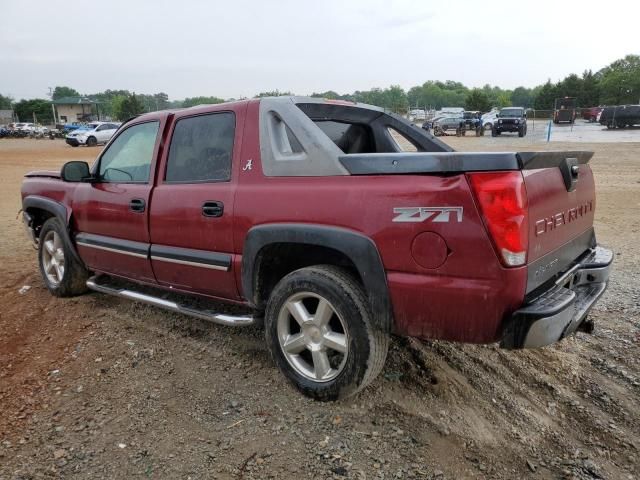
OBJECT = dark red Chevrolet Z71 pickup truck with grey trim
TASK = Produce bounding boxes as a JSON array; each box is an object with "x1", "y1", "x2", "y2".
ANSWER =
[{"x1": 22, "y1": 97, "x2": 613, "y2": 400}]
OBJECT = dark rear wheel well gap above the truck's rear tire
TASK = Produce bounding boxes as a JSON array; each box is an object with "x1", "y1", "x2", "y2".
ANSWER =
[{"x1": 253, "y1": 243, "x2": 363, "y2": 309}]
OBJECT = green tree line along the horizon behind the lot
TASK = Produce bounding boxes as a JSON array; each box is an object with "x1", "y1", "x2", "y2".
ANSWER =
[{"x1": 0, "y1": 55, "x2": 640, "y2": 123}]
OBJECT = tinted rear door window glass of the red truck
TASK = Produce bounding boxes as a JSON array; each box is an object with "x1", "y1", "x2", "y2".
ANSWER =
[{"x1": 165, "y1": 112, "x2": 236, "y2": 183}]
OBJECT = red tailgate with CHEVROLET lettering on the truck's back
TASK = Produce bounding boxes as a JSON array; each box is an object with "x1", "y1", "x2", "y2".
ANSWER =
[{"x1": 518, "y1": 152, "x2": 596, "y2": 292}]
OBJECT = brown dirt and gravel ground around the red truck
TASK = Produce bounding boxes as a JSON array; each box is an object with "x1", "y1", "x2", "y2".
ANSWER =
[{"x1": 0, "y1": 136, "x2": 640, "y2": 479}]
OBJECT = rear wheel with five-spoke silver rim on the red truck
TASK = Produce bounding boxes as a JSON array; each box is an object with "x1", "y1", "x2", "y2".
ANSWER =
[{"x1": 265, "y1": 265, "x2": 389, "y2": 401}]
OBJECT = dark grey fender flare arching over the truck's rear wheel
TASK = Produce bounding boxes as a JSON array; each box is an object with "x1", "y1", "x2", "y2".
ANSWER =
[{"x1": 242, "y1": 223, "x2": 392, "y2": 332}]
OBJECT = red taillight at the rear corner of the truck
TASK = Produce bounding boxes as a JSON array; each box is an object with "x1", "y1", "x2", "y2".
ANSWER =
[{"x1": 468, "y1": 172, "x2": 529, "y2": 267}]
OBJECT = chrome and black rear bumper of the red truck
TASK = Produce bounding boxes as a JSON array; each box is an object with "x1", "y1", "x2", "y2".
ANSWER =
[{"x1": 500, "y1": 246, "x2": 613, "y2": 349}]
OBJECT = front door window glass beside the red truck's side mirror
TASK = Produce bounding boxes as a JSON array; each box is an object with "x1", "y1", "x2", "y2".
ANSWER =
[{"x1": 98, "y1": 122, "x2": 160, "y2": 183}]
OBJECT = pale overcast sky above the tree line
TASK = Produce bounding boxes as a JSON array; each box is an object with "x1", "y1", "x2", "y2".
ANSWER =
[{"x1": 0, "y1": 0, "x2": 640, "y2": 100}]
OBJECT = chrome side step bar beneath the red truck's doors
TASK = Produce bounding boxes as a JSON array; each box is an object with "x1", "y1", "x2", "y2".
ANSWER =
[{"x1": 87, "y1": 277, "x2": 255, "y2": 327}]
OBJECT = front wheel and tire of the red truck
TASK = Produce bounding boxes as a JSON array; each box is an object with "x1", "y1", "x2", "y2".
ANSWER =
[{"x1": 38, "y1": 217, "x2": 89, "y2": 297}]
